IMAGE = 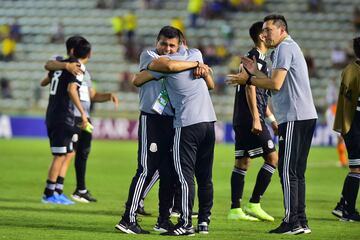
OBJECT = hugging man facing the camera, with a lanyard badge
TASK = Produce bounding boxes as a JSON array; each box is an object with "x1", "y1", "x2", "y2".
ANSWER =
[{"x1": 115, "y1": 26, "x2": 207, "y2": 234}]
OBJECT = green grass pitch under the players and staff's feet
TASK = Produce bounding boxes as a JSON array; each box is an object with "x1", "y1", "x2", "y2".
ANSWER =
[{"x1": 0, "y1": 139, "x2": 360, "y2": 240}]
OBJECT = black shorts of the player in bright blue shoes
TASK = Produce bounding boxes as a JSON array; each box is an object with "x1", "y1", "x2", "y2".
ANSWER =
[{"x1": 47, "y1": 124, "x2": 74, "y2": 156}]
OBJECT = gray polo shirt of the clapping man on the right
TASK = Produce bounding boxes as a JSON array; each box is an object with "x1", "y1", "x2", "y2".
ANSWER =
[{"x1": 271, "y1": 36, "x2": 317, "y2": 124}]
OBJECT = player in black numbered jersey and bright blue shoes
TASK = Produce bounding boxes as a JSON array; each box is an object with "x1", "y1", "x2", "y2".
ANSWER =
[{"x1": 42, "y1": 39, "x2": 91, "y2": 204}]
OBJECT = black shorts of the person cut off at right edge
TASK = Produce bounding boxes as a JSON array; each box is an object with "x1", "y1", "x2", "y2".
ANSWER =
[{"x1": 343, "y1": 111, "x2": 360, "y2": 168}]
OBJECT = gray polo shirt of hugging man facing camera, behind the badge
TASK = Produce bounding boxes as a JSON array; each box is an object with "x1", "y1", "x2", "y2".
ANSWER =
[{"x1": 139, "y1": 50, "x2": 174, "y2": 116}]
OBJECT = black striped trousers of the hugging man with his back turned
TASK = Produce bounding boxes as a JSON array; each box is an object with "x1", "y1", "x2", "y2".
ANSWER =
[{"x1": 173, "y1": 122, "x2": 215, "y2": 226}]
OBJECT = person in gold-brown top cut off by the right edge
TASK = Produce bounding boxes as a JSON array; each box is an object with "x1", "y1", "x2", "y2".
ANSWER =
[{"x1": 332, "y1": 37, "x2": 360, "y2": 222}]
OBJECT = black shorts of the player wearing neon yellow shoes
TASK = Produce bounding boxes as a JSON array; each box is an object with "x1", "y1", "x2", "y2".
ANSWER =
[{"x1": 234, "y1": 122, "x2": 276, "y2": 159}]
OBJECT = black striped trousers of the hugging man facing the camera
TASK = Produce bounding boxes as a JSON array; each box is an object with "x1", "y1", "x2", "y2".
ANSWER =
[{"x1": 123, "y1": 112, "x2": 175, "y2": 222}]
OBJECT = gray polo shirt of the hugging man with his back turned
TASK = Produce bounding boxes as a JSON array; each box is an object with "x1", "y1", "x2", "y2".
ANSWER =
[{"x1": 146, "y1": 47, "x2": 216, "y2": 127}]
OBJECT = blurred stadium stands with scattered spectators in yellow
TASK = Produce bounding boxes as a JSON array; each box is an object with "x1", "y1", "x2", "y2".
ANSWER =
[{"x1": 0, "y1": 0, "x2": 360, "y2": 121}]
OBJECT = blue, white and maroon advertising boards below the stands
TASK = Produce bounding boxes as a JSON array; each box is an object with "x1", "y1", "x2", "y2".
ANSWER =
[{"x1": 0, "y1": 115, "x2": 337, "y2": 146}]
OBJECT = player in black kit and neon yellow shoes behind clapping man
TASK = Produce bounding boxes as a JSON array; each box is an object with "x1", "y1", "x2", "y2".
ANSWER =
[{"x1": 228, "y1": 22, "x2": 278, "y2": 222}]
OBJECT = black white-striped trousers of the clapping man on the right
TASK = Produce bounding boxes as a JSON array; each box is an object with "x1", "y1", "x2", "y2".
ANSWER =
[{"x1": 279, "y1": 119, "x2": 316, "y2": 223}]
